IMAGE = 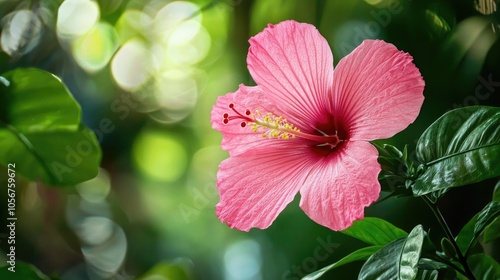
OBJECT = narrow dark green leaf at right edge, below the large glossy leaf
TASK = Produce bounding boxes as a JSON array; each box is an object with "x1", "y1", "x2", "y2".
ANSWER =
[{"x1": 455, "y1": 201, "x2": 500, "y2": 255}]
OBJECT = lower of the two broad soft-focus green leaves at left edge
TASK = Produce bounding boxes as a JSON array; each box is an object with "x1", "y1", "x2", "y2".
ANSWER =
[{"x1": 0, "y1": 126, "x2": 101, "y2": 186}]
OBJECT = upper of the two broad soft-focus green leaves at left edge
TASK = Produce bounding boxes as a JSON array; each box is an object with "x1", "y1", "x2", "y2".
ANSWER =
[{"x1": 0, "y1": 68, "x2": 81, "y2": 133}]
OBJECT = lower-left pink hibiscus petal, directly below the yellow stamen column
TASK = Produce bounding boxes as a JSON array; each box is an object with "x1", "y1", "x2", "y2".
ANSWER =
[{"x1": 216, "y1": 139, "x2": 312, "y2": 231}]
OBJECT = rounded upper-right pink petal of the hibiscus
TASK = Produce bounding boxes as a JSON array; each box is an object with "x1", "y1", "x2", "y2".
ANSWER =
[{"x1": 333, "y1": 40, "x2": 424, "y2": 141}]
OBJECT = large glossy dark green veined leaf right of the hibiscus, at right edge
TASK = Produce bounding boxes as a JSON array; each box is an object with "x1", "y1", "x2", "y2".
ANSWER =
[{"x1": 412, "y1": 106, "x2": 500, "y2": 196}]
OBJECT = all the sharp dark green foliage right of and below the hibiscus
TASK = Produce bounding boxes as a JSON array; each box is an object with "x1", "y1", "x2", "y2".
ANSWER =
[{"x1": 306, "y1": 106, "x2": 500, "y2": 280}]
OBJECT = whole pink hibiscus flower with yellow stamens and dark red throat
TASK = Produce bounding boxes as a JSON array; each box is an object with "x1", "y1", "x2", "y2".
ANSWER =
[{"x1": 211, "y1": 21, "x2": 424, "y2": 231}]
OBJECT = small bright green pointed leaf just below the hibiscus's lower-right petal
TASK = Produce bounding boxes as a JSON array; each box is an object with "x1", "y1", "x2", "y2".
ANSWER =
[{"x1": 341, "y1": 217, "x2": 408, "y2": 245}]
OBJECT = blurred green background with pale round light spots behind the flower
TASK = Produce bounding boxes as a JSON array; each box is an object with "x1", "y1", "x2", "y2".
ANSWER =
[{"x1": 0, "y1": 0, "x2": 500, "y2": 280}]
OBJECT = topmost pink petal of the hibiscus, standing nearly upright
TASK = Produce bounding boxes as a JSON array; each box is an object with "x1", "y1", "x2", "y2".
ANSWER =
[{"x1": 247, "y1": 21, "x2": 333, "y2": 128}]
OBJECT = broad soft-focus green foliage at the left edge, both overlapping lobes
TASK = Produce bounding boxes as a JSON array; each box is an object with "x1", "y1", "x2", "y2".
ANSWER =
[{"x1": 0, "y1": 68, "x2": 101, "y2": 186}]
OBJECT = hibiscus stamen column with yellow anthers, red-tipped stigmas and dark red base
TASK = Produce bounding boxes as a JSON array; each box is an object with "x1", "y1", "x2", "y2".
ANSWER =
[{"x1": 222, "y1": 103, "x2": 344, "y2": 150}]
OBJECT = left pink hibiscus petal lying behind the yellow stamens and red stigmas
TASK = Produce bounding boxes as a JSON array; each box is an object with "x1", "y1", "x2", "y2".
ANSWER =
[{"x1": 210, "y1": 85, "x2": 280, "y2": 156}]
